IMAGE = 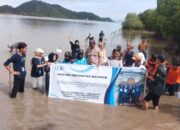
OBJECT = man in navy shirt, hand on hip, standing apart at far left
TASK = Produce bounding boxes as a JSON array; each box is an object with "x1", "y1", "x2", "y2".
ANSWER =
[{"x1": 4, "y1": 42, "x2": 27, "y2": 98}]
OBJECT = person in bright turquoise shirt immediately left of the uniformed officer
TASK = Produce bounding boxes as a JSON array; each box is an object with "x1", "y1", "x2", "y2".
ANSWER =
[{"x1": 76, "y1": 49, "x2": 87, "y2": 65}]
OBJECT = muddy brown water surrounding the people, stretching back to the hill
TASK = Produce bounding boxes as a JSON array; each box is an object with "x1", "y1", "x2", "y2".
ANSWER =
[{"x1": 0, "y1": 16, "x2": 180, "y2": 130}]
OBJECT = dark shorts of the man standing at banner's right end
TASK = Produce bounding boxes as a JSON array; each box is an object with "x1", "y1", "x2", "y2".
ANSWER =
[{"x1": 144, "y1": 93, "x2": 160, "y2": 107}]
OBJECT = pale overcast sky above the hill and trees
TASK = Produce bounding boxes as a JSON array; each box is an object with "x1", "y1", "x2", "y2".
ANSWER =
[{"x1": 0, "y1": 0, "x2": 157, "y2": 20}]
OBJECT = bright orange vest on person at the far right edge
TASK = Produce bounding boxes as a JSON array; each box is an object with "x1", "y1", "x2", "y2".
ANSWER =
[{"x1": 166, "y1": 66, "x2": 179, "y2": 85}]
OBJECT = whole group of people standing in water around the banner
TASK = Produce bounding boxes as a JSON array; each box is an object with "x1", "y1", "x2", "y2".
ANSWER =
[{"x1": 4, "y1": 32, "x2": 180, "y2": 109}]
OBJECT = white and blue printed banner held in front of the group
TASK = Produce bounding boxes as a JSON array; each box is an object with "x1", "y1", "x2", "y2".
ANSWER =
[{"x1": 49, "y1": 64, "x2": 145, "y2": 105}]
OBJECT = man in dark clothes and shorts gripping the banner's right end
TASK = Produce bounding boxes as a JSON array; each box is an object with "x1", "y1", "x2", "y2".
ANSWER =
[{"x1": 144, "y1": 55, "x2": 167, "y2": 111}]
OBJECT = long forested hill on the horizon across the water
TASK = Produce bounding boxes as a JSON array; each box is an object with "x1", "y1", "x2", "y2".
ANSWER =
[{"x1": 0, "y1": 0, "x2": 113, "y2": 22}]
